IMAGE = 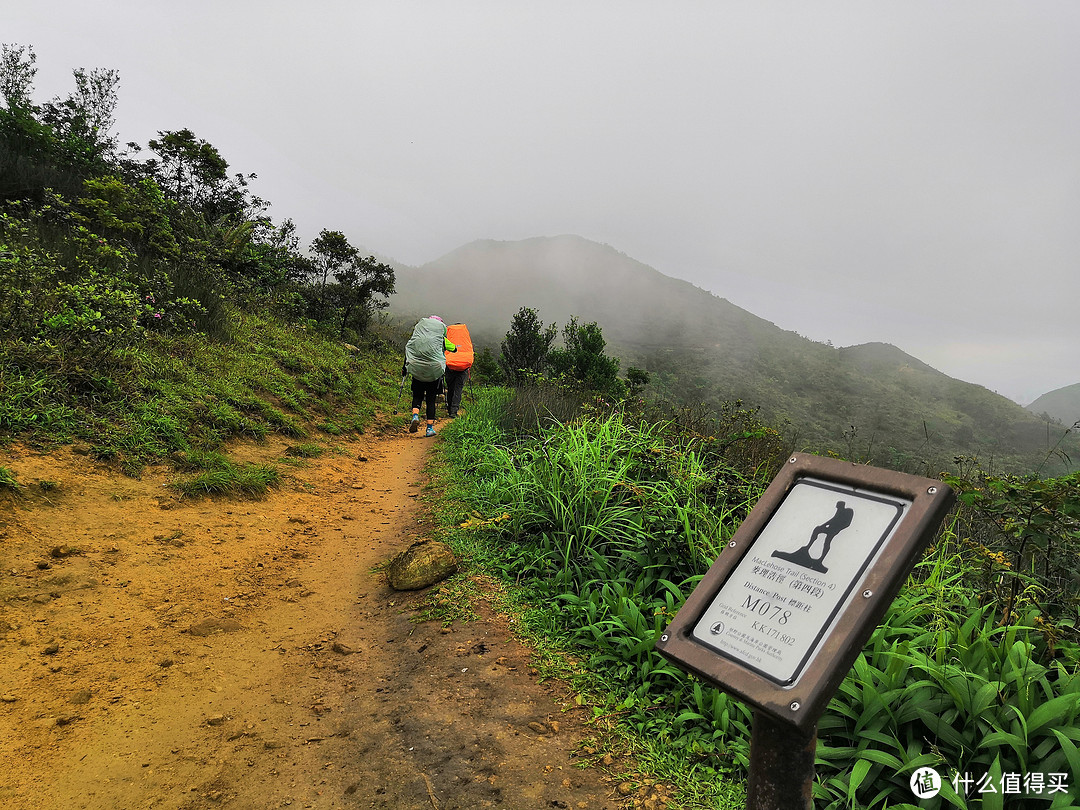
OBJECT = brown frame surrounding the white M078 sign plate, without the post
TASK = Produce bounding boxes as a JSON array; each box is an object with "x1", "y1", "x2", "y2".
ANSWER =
[{"x1": 657, "y1": 454, "x2": 955, "y2": 730}]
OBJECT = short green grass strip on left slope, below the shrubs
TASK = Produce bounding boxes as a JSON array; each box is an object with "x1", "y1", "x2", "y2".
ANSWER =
[{"x1": 0, "y1": 311, "x2": 400, "y2": 474}]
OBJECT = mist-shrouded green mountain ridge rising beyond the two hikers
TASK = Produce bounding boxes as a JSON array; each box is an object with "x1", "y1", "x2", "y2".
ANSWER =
[{"x1": 391, "y1": 235, "x2": 1080, "y2": 469}]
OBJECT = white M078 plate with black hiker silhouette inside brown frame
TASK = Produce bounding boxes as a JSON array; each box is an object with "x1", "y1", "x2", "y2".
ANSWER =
[{"x1": 691, "y1": 478, "x2": 910, "y2": 685}]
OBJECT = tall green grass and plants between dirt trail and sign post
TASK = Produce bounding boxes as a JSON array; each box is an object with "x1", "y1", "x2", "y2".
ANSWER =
[{"x1": 444, "y1": 390, "x2": 767, "y2": 793}]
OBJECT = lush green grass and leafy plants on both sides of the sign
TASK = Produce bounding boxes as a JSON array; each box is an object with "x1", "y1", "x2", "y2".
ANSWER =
[{"x1": 444, "y1": 390, "x2": 1080, "y2": 810}]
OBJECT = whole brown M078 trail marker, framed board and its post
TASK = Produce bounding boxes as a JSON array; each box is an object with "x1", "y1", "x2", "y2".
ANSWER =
[{"x1": 657, "y1": 454, "x2": 955, "y2": 810}]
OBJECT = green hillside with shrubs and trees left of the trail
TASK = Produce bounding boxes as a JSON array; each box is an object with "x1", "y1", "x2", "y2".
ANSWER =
[{"x1": 0, "y1": 44, "x2": 396, "y2": 474}]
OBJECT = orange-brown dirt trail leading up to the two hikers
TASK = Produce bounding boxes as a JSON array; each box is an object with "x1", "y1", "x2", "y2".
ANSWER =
[{"x1": 0, "y1": 431, "x2": 643, "y2": 810}]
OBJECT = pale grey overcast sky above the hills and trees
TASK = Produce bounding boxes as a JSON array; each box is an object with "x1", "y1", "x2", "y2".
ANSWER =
[{"x1": 10, "y1": 0, "x2": 1080, "y2": 403}]
